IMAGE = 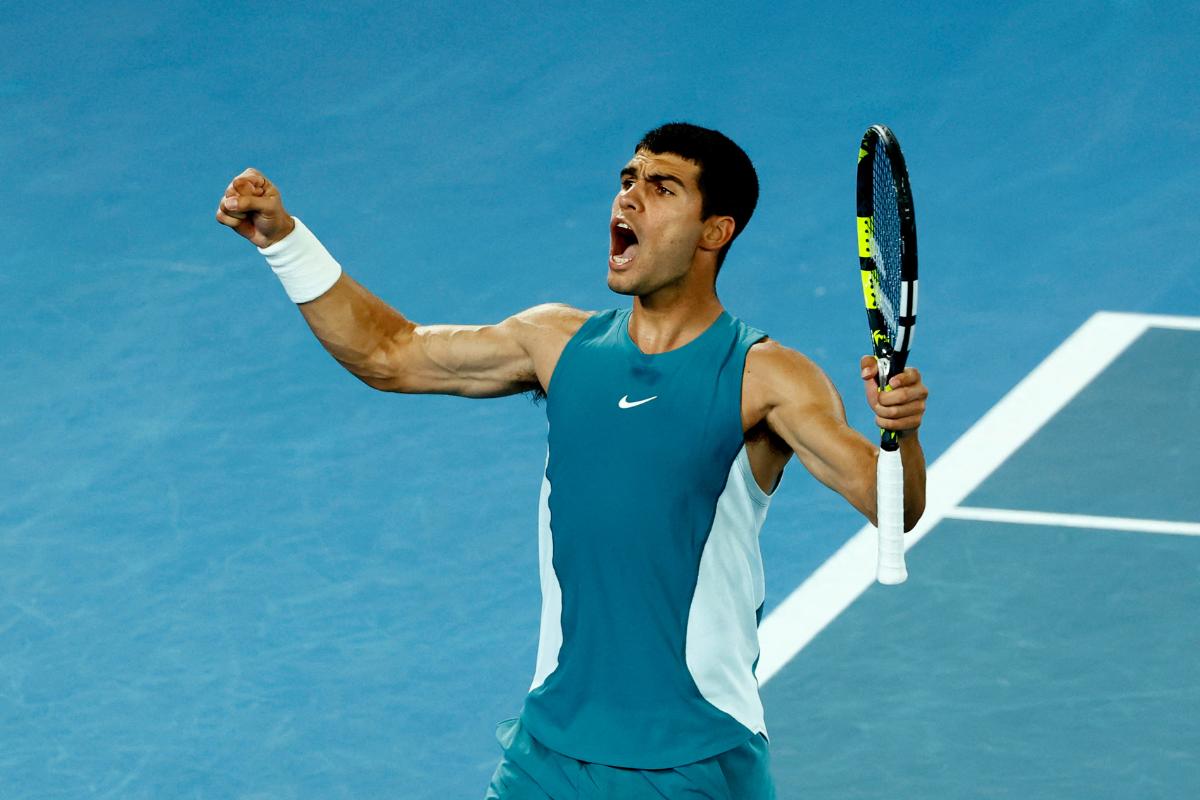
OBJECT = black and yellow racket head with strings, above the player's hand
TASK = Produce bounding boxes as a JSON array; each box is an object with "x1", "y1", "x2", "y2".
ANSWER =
[{"x1": 856, "y1": 125, "x2": 917, "y2": 450}]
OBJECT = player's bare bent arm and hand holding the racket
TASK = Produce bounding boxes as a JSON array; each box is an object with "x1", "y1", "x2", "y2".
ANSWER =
[{"x1": 746, "y1": 341, "x2": 929, "y2": 530}]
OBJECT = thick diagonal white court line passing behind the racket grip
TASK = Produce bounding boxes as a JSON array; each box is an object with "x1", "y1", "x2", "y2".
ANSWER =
[{"x1": 757, "y1": 311, "x2": 1200, "y2": 685}]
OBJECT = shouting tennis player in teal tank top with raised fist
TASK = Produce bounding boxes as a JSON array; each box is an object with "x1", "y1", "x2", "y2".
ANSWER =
[{"x1": 216, "y1": 122, "x2": 928, "y2": 800}]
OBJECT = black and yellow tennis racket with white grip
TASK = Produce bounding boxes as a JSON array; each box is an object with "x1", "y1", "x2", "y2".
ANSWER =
[{"x1": 857, "y1": 125, "x2": 917, "y2": 584}]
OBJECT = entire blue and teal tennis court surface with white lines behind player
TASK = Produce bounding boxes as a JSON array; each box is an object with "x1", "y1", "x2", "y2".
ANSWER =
[{"x1": 0, "y1": 0, "x2": 1200, "y2": 800}]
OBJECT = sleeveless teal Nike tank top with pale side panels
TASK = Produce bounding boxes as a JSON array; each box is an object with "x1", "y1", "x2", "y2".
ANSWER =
[{"x1": 521, "y1": 308, "x2": 770, "y2": 769}]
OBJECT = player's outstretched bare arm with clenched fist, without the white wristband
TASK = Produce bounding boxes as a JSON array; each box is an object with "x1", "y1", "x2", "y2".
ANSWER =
[{"x1": 217, "y1": 169, "x2": 587, "y2": 397}]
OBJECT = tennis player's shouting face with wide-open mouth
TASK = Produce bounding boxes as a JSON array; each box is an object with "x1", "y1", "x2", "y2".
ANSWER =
[{"x1": 608, "y1": 150, "x2": 704, "y2": 295}]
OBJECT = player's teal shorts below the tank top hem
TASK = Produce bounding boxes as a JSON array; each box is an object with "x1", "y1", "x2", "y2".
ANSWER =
[{"x1": 484, "y1": 720, "x2": 775, "y2": 800}]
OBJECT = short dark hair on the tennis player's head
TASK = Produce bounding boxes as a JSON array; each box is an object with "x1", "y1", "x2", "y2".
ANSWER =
[{"x1": 634, "y1": 122, "x2": 758, "y2": 272}]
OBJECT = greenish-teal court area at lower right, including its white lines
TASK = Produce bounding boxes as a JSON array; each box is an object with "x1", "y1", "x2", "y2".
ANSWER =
[{"x1": 760, "y1": 312, "x2": 1200, "y2": 800}]
